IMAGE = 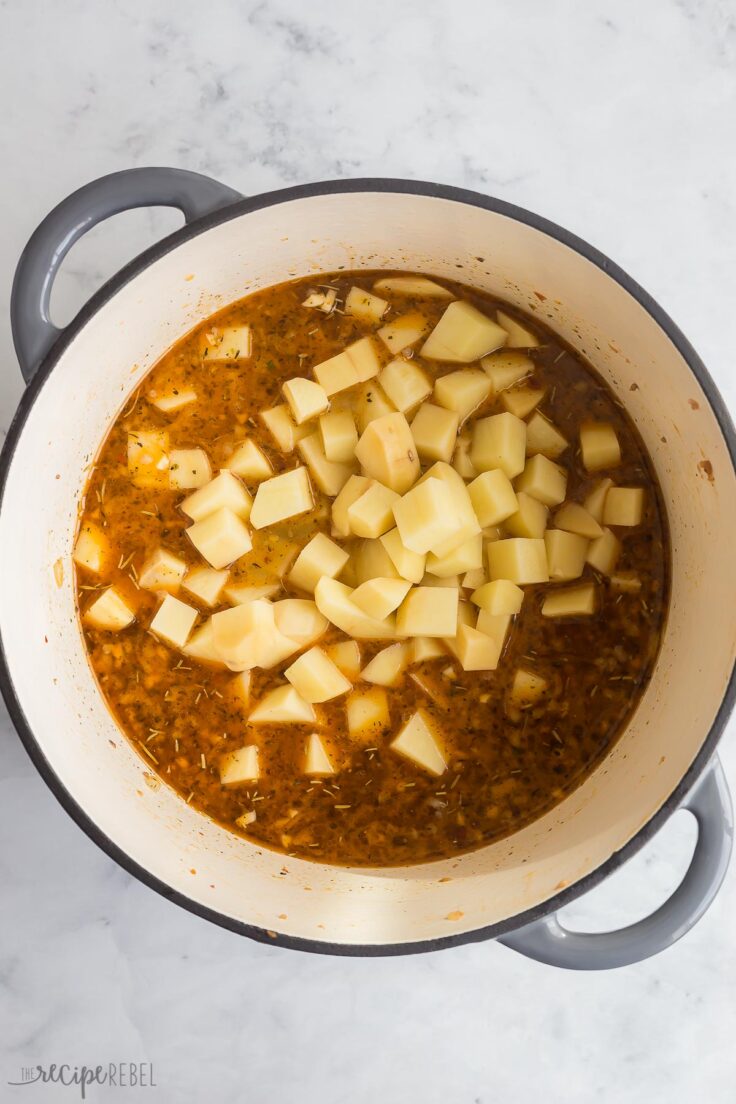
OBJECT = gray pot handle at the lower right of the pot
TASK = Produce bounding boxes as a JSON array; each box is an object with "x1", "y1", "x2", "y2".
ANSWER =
[{"x1": 499, "y1": 757, "x2": 734, "y2": 969}]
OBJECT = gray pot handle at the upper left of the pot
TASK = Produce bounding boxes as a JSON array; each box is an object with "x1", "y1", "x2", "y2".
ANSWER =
[{"x1": 10, "y1": 168, "x2": 243, "y2": 383}]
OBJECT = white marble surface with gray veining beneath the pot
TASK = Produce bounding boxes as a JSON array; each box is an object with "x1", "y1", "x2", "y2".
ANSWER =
[{"x1": 0, "y1": 0, "x2": 736, "y2": 1104}]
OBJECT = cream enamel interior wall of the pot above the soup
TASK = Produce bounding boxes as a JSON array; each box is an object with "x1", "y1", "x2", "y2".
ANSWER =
[{"x1": 0, "y1": 185, "x2": 736, "y2": 944}]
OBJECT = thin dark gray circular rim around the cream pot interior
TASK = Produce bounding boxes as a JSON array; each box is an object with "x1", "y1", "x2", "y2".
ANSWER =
[{"x1": 0, "y1": 177, "x2": 736, "y2": 957}]
